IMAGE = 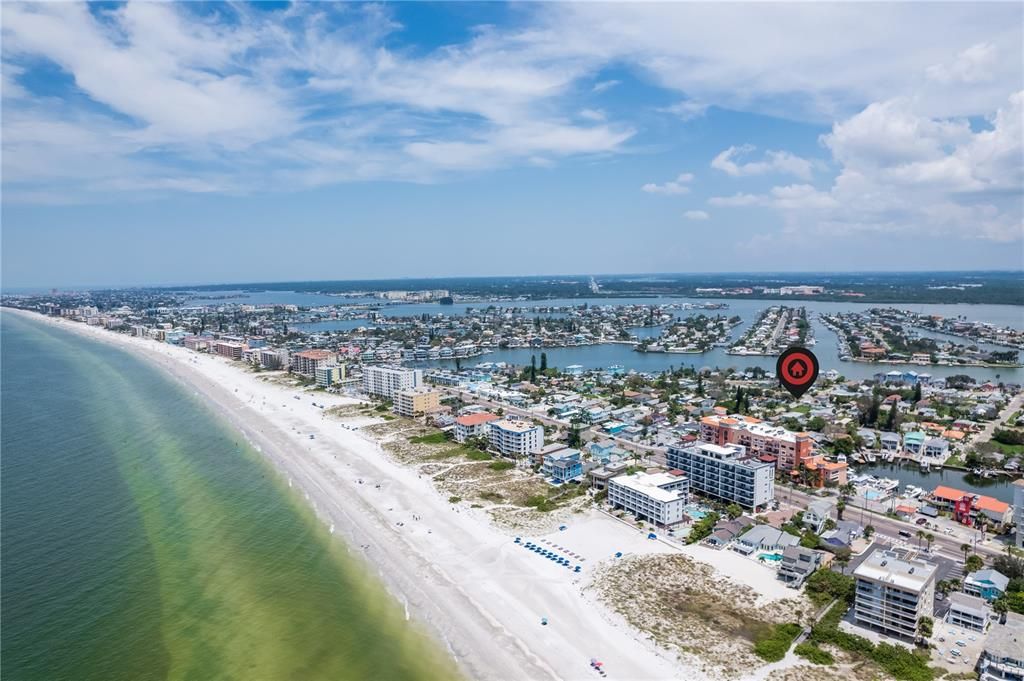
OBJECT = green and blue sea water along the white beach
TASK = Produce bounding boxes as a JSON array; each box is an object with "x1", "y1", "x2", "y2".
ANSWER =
[{"x1": 0, "y1": 313, "x2": 457, "y2": 680}]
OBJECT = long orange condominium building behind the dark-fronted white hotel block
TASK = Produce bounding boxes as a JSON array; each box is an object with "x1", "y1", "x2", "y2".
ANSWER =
[{"x1": 700, "y1": 415, "x2": 814, "y2": 470}]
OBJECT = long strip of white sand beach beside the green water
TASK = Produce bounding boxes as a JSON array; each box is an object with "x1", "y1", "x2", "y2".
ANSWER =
[{"x1": 18, "y1": 311, "x2": 704, "y2": 680}]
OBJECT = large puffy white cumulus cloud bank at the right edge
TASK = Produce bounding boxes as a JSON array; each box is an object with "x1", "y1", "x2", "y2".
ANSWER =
[{"x1": 709, "y1": 91, "x2": 1024, "y2": 242}]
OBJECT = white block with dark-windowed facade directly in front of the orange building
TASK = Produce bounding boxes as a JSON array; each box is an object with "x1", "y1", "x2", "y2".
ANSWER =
[{"x1": 668, "y1": 442, "x2": 775, "y2": 511}]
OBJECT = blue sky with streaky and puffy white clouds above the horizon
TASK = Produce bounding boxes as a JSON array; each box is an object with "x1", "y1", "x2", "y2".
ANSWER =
[{"x1": 0, "y1": 2, "x2": 1024, "y2": 288}]
